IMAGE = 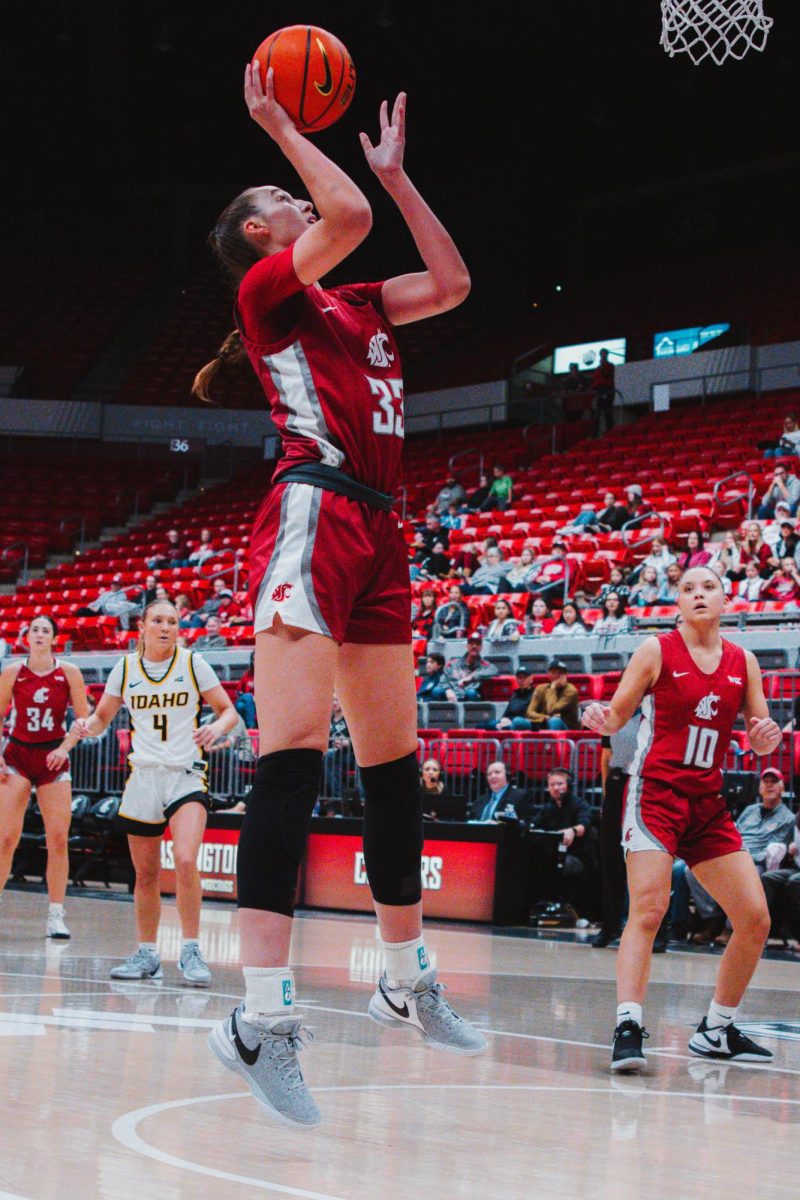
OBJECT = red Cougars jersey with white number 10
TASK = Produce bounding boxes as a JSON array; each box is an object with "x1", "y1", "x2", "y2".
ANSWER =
[{"x1": 631, "y1": 630, "x2": 747, "y2": 796}]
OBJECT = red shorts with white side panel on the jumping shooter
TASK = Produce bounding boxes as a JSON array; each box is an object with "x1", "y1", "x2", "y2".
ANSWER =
[{"x1": 249, "y1": 484, "x2": 411, "y2": 646}]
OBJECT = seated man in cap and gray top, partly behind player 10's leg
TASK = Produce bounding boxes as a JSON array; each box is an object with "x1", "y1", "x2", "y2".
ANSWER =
[{"x1": 686, "y1": 767, "x2": 795, "y2": 946}]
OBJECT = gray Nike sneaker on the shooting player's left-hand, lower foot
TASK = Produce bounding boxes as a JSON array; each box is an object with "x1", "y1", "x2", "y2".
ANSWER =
[{"x1": 209, "y1": 1004, "x2": 323, "y2": 1129}]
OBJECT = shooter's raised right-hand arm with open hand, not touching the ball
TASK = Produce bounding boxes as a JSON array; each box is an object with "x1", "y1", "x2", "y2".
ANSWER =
[{"x1": 361, "y1": 91, "x2": 470, "y2": 325}]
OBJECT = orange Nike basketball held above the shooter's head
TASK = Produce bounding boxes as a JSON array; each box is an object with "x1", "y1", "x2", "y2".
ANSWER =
[{"x1": 253, "y1": 25, "x2": 355, "y2": 133}]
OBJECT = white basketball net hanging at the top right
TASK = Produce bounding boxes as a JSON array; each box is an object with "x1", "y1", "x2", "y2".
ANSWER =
[{"x1": 661, "y1": 0, "x2": 772, "y2": 66}]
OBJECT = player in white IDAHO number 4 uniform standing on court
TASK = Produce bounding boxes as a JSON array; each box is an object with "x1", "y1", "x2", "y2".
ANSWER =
[{"x1": 68, "y1": 600, "x2": 237, "y2": 986}]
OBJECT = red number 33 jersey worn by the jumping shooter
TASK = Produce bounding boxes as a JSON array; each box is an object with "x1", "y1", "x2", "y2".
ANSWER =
[{"x1": 236, "y1": 246, "x2": 404, "y2": 492}]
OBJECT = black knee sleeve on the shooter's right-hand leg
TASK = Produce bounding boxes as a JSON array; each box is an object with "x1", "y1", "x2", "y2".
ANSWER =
[{"x1": 360, "y1": 754, "x2": 422, "y2": 905}]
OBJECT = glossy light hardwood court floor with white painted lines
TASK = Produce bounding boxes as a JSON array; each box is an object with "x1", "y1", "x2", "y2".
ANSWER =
[{"x1": 0, "y1": 892, "x2": 800, "y2": 1200}]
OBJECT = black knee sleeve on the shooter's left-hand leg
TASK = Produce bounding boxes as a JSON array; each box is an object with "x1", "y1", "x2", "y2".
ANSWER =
[{"x1": 236, "y1": 750, "x2": 323, "y2": 917}]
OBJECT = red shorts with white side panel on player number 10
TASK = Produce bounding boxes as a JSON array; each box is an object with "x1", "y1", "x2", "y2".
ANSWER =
[{"x1": 622, "y1": 775, "x2": 742, "y2": 866}]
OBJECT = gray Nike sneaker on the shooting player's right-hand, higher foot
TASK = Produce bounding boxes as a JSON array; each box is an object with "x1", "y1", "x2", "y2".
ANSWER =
[{"x1": 367, "y1": 971, "x2": 487, "y2": 1054}]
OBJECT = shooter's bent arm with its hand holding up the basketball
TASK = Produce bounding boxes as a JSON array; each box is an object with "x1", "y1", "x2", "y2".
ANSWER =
[{"x1": 245, "y1": 62, "x2": 372, "y2": 286}]
